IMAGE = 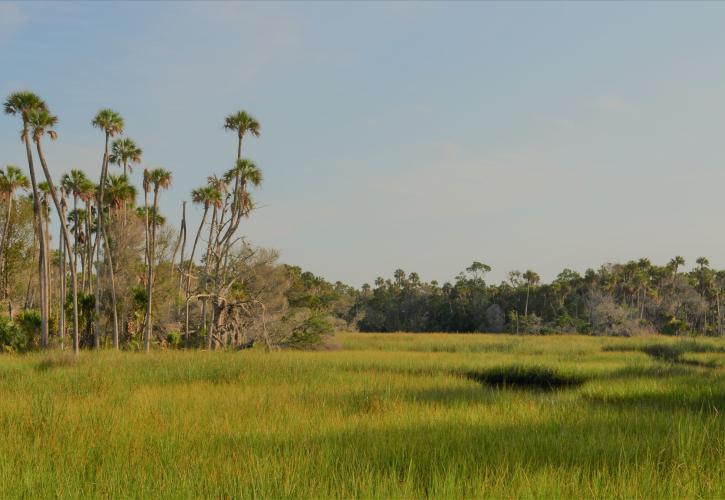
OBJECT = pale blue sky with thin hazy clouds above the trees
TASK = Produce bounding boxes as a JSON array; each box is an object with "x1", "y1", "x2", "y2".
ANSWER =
[{"x1": 0, "y1": 1, "x2": 725, "y2": 286}]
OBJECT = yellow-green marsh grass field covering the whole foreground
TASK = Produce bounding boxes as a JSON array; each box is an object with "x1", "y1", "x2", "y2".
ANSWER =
[{"x1": 0, "y1": 334, "x2": 725, "y2": 498}]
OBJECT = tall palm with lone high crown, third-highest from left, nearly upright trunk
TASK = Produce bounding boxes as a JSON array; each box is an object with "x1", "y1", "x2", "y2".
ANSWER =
[{"x1": 91, "y1": 109, "x2": 124, "y2": 349}]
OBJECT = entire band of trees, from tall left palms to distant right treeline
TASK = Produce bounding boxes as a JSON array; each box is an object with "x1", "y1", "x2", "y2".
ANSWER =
[{"x1": 0, "y1": 92, "x2": 725, "y2": 352}]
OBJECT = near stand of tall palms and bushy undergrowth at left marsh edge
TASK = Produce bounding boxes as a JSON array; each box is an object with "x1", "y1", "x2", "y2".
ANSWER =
[{"x1": 0, "y1": 91, "x2": 332, "y2": 353}]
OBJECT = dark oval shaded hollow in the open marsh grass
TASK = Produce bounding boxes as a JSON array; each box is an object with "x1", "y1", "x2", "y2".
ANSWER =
[{"x1": 462, "y1": 365, "x2": 587, "y2": 391}]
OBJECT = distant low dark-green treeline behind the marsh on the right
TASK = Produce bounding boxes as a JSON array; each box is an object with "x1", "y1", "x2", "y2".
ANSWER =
[{"x1": 288, "y1": 257, "x2": 725, "y2": 336}]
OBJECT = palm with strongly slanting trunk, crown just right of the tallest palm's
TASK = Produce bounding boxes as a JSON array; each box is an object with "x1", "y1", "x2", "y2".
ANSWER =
[{"x1": 28, "y1": 108, "x2": 79, "y2": 354}]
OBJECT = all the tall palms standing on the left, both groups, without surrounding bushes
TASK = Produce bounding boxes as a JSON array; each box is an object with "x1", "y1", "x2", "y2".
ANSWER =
[{"x1": 0, "y1": 91, "x2": 263, "y2": 353}]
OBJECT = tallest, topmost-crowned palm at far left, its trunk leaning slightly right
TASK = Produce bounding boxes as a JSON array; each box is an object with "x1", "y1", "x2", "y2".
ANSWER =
[{"x1": 4, "y1": 91, "x2": 48, "y2": 346}]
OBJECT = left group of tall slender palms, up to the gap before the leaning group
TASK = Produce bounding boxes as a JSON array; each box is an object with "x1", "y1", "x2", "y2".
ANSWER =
[{"x1": 0, "y1": 91, "x2": 177, "y2": 353}]
